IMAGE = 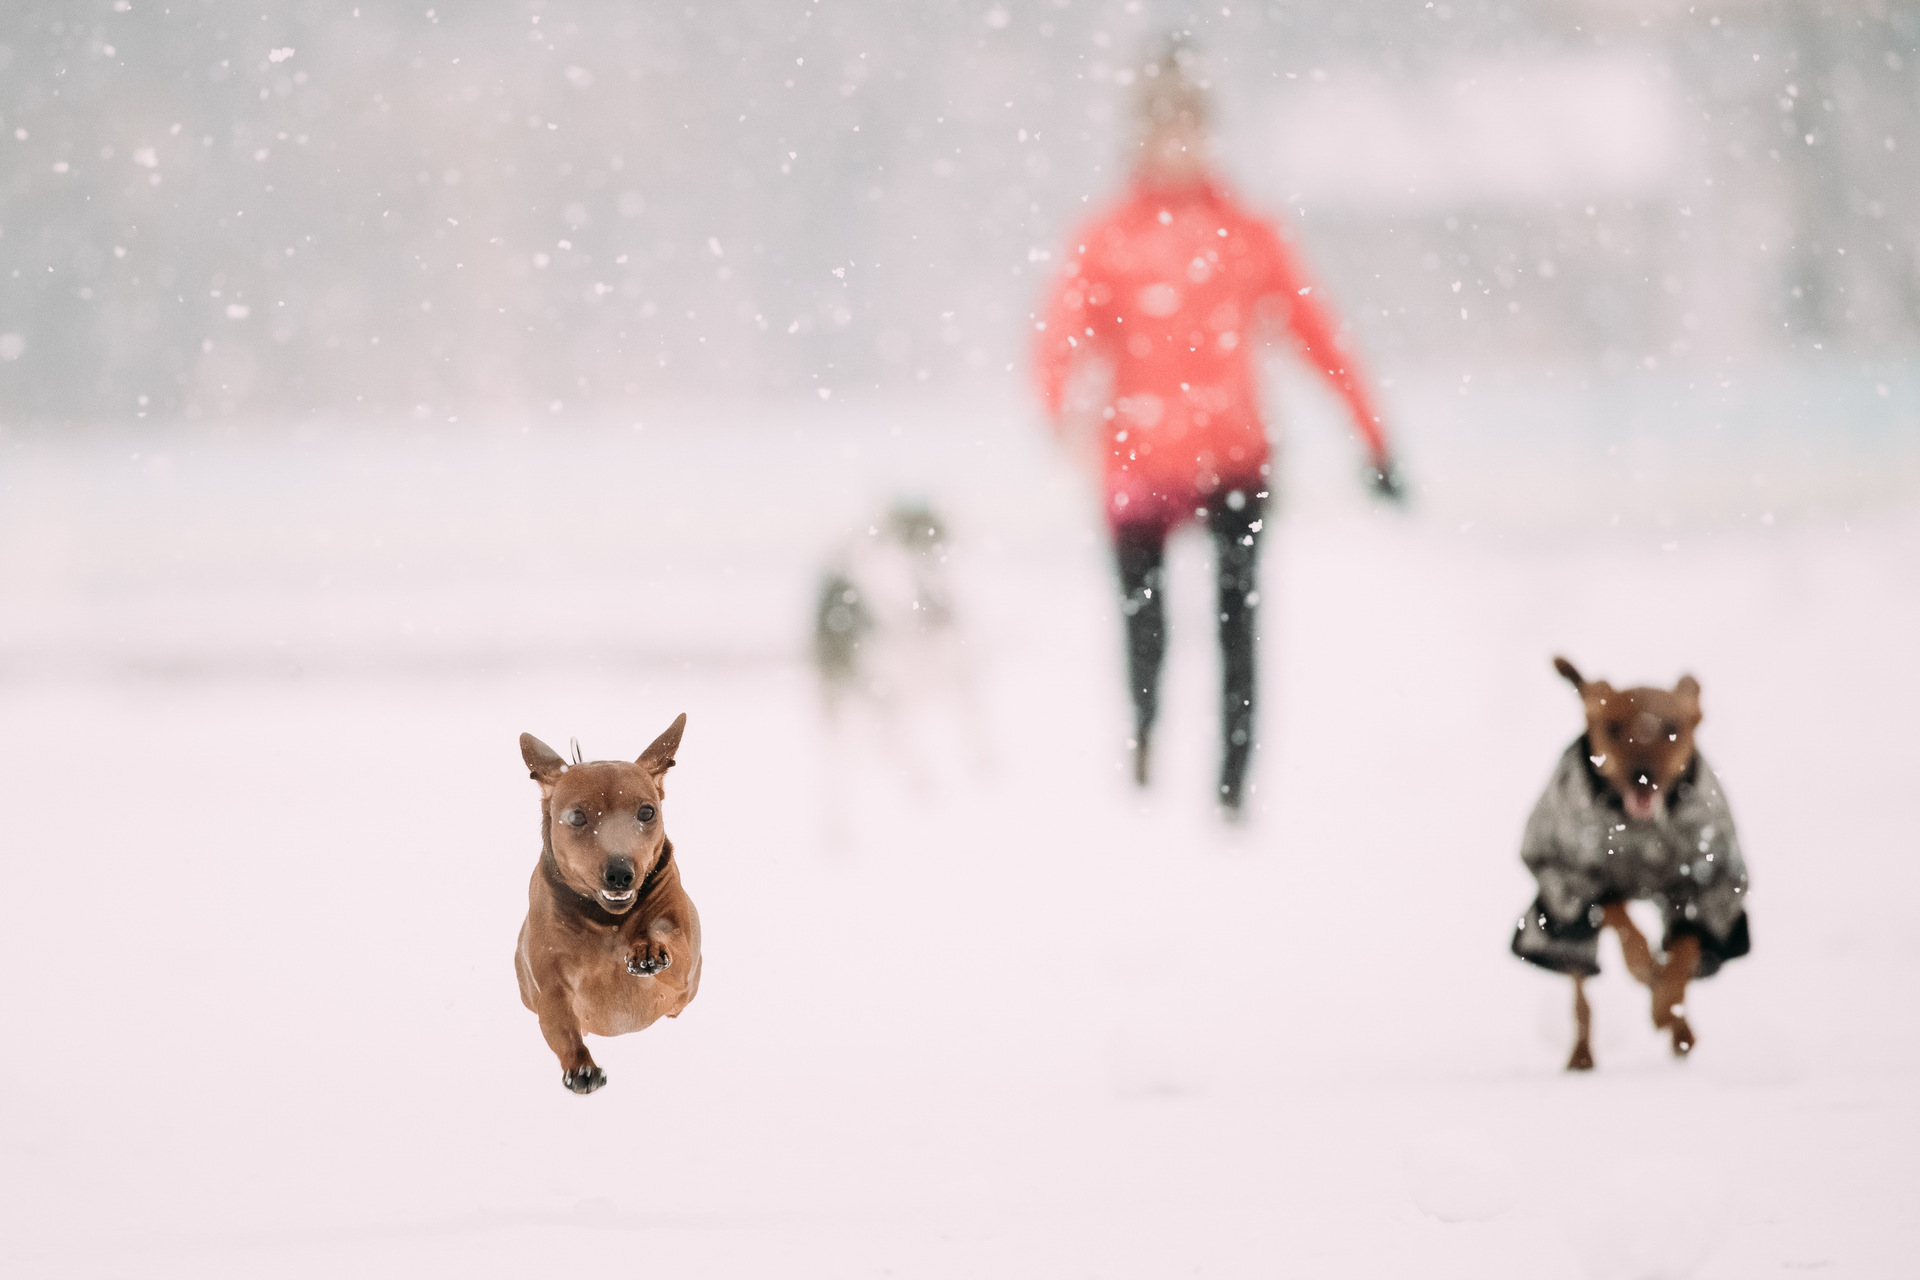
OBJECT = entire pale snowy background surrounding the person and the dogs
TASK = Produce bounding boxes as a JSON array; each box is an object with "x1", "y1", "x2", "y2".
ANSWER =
[{"x1": 0, "y1": 0, "x2": 1920, "y2": 1280}]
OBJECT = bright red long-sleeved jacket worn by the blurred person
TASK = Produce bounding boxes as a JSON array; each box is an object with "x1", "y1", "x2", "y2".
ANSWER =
[{"x1": 1035, "y1": 180, "x2": 1386, "y2": 524}]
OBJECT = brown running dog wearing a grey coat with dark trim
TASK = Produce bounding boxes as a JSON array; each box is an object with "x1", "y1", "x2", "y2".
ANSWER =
[{"x1": 1513, "y1": 658, "x2": 1749, "y2": 1071}]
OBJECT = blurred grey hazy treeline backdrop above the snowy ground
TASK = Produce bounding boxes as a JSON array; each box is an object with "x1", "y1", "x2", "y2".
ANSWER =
[{"x1": 0, "y1": 0, "x2": 1920, "y2": 422}]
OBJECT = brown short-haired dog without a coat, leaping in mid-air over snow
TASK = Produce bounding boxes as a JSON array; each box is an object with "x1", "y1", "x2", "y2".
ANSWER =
[{"x1": 513, "y1": 716, "x2": 701, "y2": 1094}]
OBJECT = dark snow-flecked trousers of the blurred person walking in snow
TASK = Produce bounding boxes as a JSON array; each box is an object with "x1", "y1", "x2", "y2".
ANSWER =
[{"x1": 1114, "y1": 487, "x2": 1265, "y2": 804}]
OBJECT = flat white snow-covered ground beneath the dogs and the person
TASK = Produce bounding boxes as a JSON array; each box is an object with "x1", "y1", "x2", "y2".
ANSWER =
[{"x1": 0, "y1": 383, "x2": 1920, "y2": 1280}]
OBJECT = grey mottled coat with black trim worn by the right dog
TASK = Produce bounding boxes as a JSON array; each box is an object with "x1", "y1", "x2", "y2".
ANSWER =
[{"x1": 1513, "y1": 733, "x2": 1749, "y2": 977}]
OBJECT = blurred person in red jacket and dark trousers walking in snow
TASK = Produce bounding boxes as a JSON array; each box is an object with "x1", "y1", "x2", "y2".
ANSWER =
[{"x1": 1035, "y1": 42, "x2": 1402, "y2": 819}]
